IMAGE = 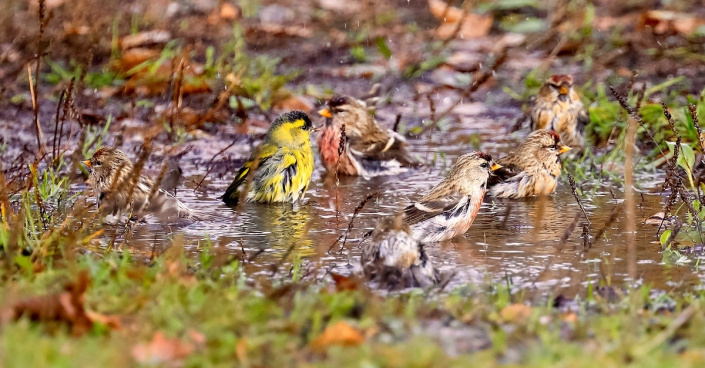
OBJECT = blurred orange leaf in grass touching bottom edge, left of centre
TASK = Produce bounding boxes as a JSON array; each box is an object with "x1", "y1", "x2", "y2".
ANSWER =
[{"x1": 132, "y1": 331, "x2": 194, "y2": 365}]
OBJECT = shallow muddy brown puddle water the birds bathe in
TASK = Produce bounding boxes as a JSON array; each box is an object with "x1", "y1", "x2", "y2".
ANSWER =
[{"x1": 96, "y1": 121, "x2": 705, "y2": 294}]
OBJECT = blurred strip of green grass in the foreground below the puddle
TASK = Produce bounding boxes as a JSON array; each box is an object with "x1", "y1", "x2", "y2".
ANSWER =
[{"x1": 0, "y1": 242, "x2": 705, "y2": 367}]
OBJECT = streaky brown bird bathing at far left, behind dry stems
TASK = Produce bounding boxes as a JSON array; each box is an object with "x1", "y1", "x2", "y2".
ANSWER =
[{"x1": 83, "y1": 147, "x2": 197, "y2": 223}]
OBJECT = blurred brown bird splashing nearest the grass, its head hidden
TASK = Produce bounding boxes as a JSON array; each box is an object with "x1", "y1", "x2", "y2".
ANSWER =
[{"x1": 361, "y1": 214, "x2": 440, "y2": 289}]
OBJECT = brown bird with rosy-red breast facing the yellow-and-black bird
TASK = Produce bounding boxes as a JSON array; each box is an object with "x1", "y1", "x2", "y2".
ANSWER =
[{"x1": 318, "y1": 96, "x2": 421, "y2": 178}]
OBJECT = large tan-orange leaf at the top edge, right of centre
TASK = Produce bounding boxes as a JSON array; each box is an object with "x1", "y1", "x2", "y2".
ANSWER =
[{"x1": 428, "y1": 0, "x2": 493, "y2": 40}]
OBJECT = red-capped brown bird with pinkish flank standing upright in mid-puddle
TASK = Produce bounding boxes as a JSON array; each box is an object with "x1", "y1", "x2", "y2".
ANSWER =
[{"x1": 404, "y1": 152, "x2": 501, "y2": 243}]
